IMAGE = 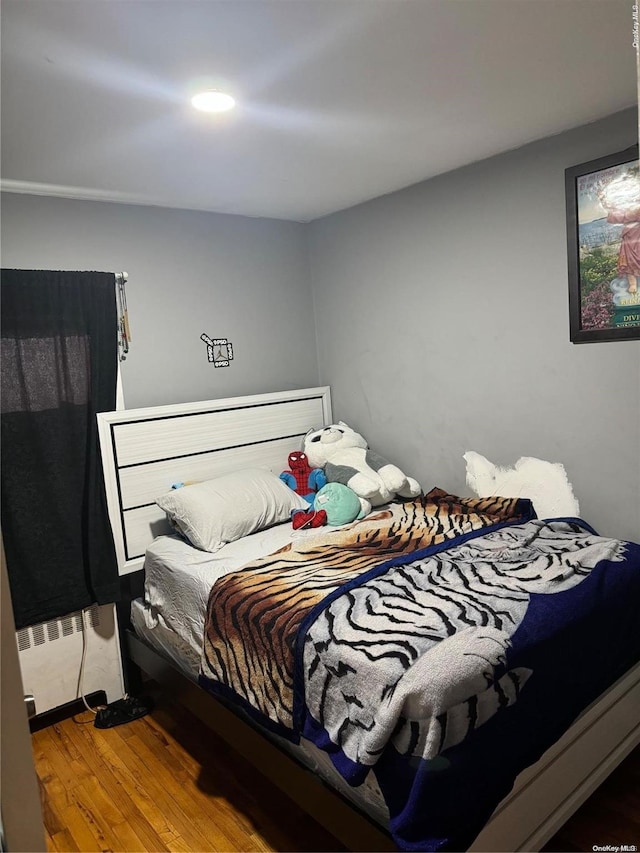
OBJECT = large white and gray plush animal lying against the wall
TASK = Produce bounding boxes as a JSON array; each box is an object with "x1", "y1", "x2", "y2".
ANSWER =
[{"x1": 304, "y1": 421, "x2": 422, "y2": 506}]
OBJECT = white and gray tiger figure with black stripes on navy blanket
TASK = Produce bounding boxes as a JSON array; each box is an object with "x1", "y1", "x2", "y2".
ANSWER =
[{"x1": 303, "y1": 520, "x2": 624, "y2": 781}]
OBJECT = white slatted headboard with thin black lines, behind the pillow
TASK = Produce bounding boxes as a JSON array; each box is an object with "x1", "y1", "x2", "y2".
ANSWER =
[{"x1": 97, "y1": 386, "x2": 331, "y2": 575}]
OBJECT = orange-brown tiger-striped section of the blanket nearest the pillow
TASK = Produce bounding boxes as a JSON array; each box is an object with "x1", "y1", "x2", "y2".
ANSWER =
[{"x1": 201, "y1": 489, "x2": 533, "y2": 736}]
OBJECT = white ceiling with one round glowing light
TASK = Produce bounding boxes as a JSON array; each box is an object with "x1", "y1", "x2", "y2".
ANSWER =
[{"x1": 1, "y1": 0, "x2": 638, "y2": 222}]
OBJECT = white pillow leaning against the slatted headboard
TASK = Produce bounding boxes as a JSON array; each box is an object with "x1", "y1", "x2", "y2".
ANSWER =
[{"x1": 156, "y1": 468, "x2": 309, "y2": 552}]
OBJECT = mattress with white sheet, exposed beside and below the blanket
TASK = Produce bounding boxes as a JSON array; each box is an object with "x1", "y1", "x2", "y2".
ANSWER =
[{"x1": 131, "y1": 523, "x2": 389, "y2": 827}]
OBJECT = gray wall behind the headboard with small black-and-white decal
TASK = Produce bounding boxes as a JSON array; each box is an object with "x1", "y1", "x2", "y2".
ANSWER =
[{"x1": 2, "y1": 193, "x2": 318, "y2": 408}]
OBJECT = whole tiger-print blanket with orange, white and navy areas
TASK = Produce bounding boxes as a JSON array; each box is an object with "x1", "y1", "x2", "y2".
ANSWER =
[{"x1": 200, "y1": 489, "x2": 640, "y2": 850}]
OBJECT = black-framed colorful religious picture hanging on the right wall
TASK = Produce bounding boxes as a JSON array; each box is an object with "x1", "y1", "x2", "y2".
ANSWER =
[{"x1": 565, "y1": 145, "x2": 640, "y2": 344}]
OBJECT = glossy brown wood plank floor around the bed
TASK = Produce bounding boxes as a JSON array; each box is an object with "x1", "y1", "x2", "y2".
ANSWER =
[{"x1": 32, "y1": 697, "x2": 640, "y2": 853}]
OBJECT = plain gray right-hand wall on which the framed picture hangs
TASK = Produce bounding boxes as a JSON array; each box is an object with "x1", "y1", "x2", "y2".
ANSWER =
[{"x1": 308, "y1": 110, "x2": 640, "y2": 539}]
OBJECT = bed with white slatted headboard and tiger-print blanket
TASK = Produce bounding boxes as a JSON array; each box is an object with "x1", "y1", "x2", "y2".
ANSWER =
[{"x1": 98, "y1": 387, "x2": 640, "y2": 851}]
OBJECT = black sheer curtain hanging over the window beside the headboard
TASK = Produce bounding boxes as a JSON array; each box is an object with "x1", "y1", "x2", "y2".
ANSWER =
[{"x1": 0, "y1": 270, "x2": 119, "y2": 628}]
